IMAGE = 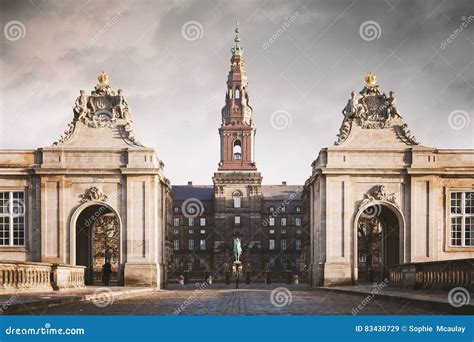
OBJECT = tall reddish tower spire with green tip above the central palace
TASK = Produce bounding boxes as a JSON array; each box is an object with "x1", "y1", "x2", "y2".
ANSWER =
[{"x1": 219, "y1": 26, "x2": 257, "y2": 170}]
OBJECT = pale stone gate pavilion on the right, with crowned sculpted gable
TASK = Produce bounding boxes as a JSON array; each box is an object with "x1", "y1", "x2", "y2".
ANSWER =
[{"x1": 304, "y1": 74, "x2": 474, "y2": 286}]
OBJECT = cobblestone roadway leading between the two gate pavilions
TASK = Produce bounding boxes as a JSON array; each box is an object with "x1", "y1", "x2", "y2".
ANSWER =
[{"x1": 24, "y1": 284, "x2": 445, "y2": 315}]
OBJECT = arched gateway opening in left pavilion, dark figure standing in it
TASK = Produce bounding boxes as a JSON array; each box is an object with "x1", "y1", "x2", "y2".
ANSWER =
[{"x1": 76, "y1": 204, "x2": 121, "y2": 286}]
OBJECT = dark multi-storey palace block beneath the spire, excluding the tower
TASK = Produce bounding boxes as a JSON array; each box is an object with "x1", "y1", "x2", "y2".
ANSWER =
[{"x1": 170, "y1": 183, "x2": 310, "y2": 281}]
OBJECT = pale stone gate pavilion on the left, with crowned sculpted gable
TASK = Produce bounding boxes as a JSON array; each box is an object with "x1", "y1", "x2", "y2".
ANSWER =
[{"x1": 0, "y1": 74, "x2": 171, "y2": 287}]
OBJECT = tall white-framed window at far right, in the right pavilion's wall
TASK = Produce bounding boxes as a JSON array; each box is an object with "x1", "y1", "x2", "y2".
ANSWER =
[{"x1": 449, "y1": 191, "x2": 474, "y2": 247}]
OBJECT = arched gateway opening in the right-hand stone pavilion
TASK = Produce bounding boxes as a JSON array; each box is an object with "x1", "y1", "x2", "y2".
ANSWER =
[{"x1": 357, "y1": 204, "x2": 402, "y2": 282}]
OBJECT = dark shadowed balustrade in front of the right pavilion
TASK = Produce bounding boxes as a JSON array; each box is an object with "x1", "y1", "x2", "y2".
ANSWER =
[{"x1": 388, "y1": 259, "x2": 474, "y2": 290}]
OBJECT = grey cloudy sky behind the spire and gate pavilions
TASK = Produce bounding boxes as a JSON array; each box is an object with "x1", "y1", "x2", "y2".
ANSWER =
[{"x1": 0, "y1": 0, "x2": 474, "y2": 184}]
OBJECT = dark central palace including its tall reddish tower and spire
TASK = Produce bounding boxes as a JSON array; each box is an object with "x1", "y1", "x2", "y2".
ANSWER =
[{"x1": 170, "y1": 28, "x2": 310, "y2": 281}]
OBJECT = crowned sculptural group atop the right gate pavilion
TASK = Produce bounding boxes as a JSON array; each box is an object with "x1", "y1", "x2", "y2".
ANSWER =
[{"x1": 335, "y1": 73, "x2": 419, "y2": 145}]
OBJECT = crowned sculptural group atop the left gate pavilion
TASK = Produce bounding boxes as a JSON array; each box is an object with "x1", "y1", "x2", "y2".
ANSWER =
[{"x1": 53, "y1": 72, "x2": 142, "y2": 146}]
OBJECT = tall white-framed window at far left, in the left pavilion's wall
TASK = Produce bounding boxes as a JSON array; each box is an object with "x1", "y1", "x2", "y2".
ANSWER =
[{"x1": 0, "y1": 191, "x2": 25, "y2": 246}]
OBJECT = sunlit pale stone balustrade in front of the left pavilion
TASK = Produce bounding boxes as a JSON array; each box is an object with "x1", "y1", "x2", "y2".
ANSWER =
[{"x1": 0, "y1": 261, "x2": 85, "y2": 293}]
